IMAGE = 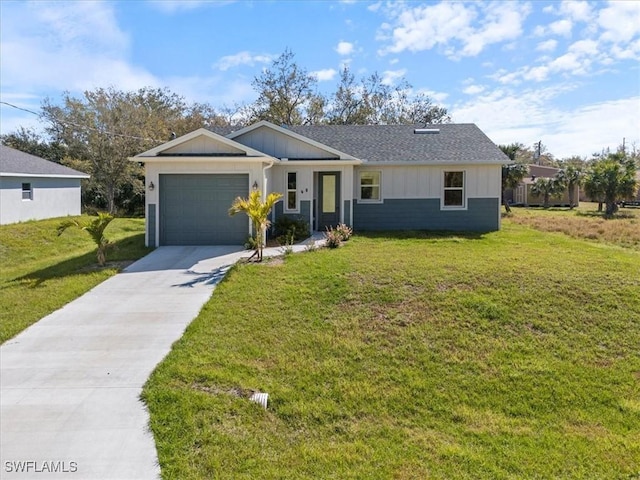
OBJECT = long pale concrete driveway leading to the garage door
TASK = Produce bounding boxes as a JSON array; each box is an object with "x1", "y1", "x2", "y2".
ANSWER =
[{"x1": 0, "y1": 247, "x2": 258, "y2": 480}]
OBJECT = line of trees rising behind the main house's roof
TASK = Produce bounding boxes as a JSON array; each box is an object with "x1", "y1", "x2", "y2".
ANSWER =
[{"x1": 0, "y1": 50, "x2": 450, "y2": 214}]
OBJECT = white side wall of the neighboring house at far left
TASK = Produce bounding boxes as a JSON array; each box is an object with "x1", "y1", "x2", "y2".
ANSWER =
[{"x1": 0, "y1": 177, "x2": 82, "y2": 225}]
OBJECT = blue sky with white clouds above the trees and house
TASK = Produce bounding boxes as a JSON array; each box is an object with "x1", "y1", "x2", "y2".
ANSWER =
[{"x1": 0, "y1": 0, "x2": 640, "y2": 158}]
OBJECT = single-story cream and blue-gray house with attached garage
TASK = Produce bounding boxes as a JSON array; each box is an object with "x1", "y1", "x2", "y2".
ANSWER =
[{"x1": 130, "y1": 121, "x2": 509, "y2": 246}]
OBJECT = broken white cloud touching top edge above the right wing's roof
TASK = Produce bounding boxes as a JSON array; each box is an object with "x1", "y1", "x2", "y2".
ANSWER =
[{"x1": 378, "y1": 2, "x2": 530, "y2": 58}]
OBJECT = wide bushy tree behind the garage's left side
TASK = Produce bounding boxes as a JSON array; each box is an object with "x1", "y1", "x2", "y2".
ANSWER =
[{"x1": 42, "y1": 88, "x2": 225, "y2": 214}]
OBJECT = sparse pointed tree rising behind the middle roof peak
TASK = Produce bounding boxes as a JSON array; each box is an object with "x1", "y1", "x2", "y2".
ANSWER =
[{"x1": 249, "y1": 49, "x2": 323, "y2": 125}]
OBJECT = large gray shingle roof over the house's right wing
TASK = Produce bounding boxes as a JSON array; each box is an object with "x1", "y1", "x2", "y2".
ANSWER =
[{"x1": 213, "y1": 123, "x2": 509, "y2": 163}]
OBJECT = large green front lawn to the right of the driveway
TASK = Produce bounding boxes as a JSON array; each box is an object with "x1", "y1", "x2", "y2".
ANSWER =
[{"x1": 143, "y1": 219, "x2": 640, "y2": 479}]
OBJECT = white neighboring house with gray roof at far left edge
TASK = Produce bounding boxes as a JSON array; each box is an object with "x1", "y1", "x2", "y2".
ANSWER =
[{"x1": 0, "y1": 145, "x2": 89, "y2": 225}]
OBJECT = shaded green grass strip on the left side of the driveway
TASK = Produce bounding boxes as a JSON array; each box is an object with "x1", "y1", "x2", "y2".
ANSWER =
[{"x1": 0, "y1": 218, "x2": 149, "y2": 342}]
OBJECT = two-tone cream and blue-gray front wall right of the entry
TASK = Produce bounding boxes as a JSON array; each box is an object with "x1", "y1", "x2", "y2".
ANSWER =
[{"x1": 353, "y1": 165, "x2": 501, "y2": 231}]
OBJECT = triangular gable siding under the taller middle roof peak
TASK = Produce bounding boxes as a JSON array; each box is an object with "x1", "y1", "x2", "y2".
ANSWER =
[{"x1": 234, "y1": 127, "x2": 334, "y2": 160}]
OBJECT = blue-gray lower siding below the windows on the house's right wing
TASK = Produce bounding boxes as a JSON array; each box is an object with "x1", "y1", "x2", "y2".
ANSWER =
[{"x1": 353, "y1": 198, "x2": 500, "y2": 232}]
